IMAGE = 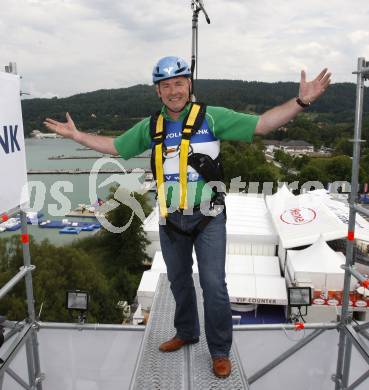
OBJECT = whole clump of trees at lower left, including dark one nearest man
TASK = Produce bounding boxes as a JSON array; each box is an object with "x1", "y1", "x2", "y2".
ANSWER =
[{"x1": 0, "y1": 190, "x2": 150, "y2": 323}]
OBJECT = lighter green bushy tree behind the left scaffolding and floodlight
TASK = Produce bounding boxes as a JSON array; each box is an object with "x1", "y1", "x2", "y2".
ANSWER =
[{"x1": 0, "y1": 237, "x2": 114, "y2": 322}]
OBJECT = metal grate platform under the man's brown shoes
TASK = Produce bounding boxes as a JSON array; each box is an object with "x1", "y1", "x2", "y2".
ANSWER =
[{"x1": 130, "y1": 274, "x2": 249, "y2": 390}]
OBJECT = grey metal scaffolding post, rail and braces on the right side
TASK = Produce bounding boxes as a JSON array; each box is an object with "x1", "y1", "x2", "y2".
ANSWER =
[{"x1": 239, "y1": 57, "x2": 369, "y2": 390}]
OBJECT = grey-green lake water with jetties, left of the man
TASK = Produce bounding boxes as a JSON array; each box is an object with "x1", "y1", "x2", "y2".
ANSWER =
[{"x1": 0, "y1": 138, "x2": 153, "y2": 245}]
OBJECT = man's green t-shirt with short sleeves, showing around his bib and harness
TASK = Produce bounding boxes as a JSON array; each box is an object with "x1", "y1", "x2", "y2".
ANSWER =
[{"x1": 114, "y1": 105, "x2": 259, "y2": 207}]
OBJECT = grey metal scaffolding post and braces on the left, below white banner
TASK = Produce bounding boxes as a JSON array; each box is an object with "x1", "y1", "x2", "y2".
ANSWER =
[{"x1": 0, "y1": 63, "x2": 44, "y2": 390}]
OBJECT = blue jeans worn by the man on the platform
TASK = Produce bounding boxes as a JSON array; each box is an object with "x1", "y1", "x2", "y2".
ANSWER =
[{"x1": 159, "y1": 211, "x2": 232, "y2": 357}]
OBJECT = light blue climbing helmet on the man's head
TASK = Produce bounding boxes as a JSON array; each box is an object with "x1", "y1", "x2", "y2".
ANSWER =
[{"x1": 152, "y1": 56, "x2": 191, "y2": 84}]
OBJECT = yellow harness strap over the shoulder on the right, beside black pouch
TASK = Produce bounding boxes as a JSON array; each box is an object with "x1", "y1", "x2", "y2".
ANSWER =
[{"x1": 179, "y1": 103, "x2": 201, "y2": 209}]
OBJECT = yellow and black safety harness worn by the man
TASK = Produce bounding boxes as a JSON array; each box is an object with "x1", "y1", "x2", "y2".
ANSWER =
[{"x1": 150, "y1": 102, "x2": 224, "y2": 236}]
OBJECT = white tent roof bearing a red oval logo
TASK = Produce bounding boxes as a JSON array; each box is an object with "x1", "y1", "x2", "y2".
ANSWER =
[{"x1": 266, "y1": 187, "x2": 347, "y2": 248}]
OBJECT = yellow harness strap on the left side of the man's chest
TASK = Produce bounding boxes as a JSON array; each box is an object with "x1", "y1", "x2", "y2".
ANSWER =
[{"x1": 154, "y1": 114, "x2": 168, "y2": 218}]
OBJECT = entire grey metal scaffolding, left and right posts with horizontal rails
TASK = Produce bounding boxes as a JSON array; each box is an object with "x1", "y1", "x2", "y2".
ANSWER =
[{"x1": 0, "y1": 57, "x2": 369, "y2": 390}]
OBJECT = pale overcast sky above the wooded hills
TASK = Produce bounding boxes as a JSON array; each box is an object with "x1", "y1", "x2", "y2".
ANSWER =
[{"x1": 0, "y1": 0, "x2": 369, "y2": 98}]
